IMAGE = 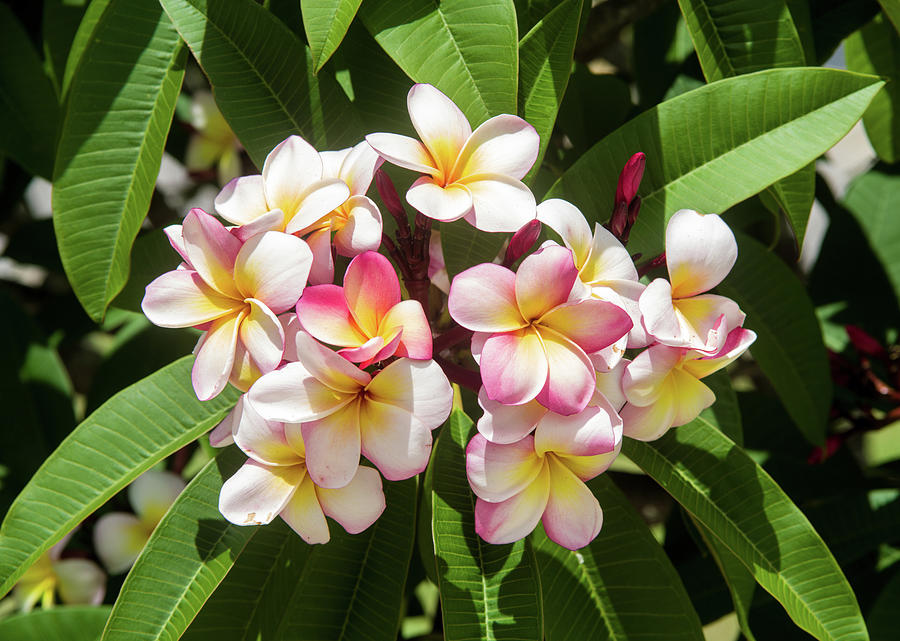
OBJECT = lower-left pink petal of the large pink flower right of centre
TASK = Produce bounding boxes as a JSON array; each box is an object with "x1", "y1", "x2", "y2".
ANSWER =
[{"x1": 481, "y1": 328, "x2": 549, "y2": 405}]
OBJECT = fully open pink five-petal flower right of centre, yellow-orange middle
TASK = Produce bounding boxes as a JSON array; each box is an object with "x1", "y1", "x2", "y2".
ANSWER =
[{"x1": 448, "y1": 246, "x2": 631, "y2": 415}]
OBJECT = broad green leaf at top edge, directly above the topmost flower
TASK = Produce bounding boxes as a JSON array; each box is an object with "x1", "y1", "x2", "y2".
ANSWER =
[{"x1": 359, "y1": 0, "x2": 519, "y2": 127}]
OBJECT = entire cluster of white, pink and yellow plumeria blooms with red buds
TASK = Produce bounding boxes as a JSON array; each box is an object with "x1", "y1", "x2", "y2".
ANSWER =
[{"x1": 143, "y1": 85, "x2": 755, "y2": 549}]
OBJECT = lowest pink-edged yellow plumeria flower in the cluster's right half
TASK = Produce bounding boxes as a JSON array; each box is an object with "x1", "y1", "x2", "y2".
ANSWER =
[{"x1": 466, "y1": 408, "x2": 622, "y2": 550}]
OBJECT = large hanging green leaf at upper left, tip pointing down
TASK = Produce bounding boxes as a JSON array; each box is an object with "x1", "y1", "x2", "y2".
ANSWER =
[{"x1": 53, "y1": 0, "x2": 186, "y2": 321}]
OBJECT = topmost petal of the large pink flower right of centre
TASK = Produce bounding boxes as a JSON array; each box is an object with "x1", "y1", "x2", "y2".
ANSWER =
[{"x1": 512, "y1": 246, "x2": 576, "y2": 322}]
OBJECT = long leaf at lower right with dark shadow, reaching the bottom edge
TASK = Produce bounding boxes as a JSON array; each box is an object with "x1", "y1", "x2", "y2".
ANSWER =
[{"x1": 623, "y1": 418, "x2": 868, "y2": 641}]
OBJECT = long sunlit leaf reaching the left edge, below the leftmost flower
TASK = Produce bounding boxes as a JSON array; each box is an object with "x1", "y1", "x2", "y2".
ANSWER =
[{"x1": 0, "y1": 356, "x2": 238, "y2": 594}]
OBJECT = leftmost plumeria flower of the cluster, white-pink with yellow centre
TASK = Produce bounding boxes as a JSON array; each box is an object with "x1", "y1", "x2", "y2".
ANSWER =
[{"x1": 141, "y1": 209, "x2": 312, "y2": 401}]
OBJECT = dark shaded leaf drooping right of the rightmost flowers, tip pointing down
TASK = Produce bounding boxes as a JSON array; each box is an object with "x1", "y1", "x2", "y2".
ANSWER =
[{"x1": 718, "y1": 233, "x2": 832, "y2": 445}]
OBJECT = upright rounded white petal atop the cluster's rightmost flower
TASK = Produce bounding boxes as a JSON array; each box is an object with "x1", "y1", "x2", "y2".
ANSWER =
[{"x1": 666, "y1": 209, "x2": 737, "y2": 298}]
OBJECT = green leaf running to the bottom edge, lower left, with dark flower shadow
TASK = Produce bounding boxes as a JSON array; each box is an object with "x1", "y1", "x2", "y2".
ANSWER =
[{"x1": 102, "y1": 447, "x2": 251, "y2": 641}]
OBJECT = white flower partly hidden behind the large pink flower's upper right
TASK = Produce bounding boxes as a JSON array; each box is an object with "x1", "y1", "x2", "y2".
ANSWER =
[{"x1": 537, "y1": 198, "x2": 650, "y2": 350}]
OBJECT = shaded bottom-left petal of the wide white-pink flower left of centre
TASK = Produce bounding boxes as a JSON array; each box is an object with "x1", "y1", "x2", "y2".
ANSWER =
[{"x1": 300, "y1": 403, "x2": 360, "y2": 488}]
